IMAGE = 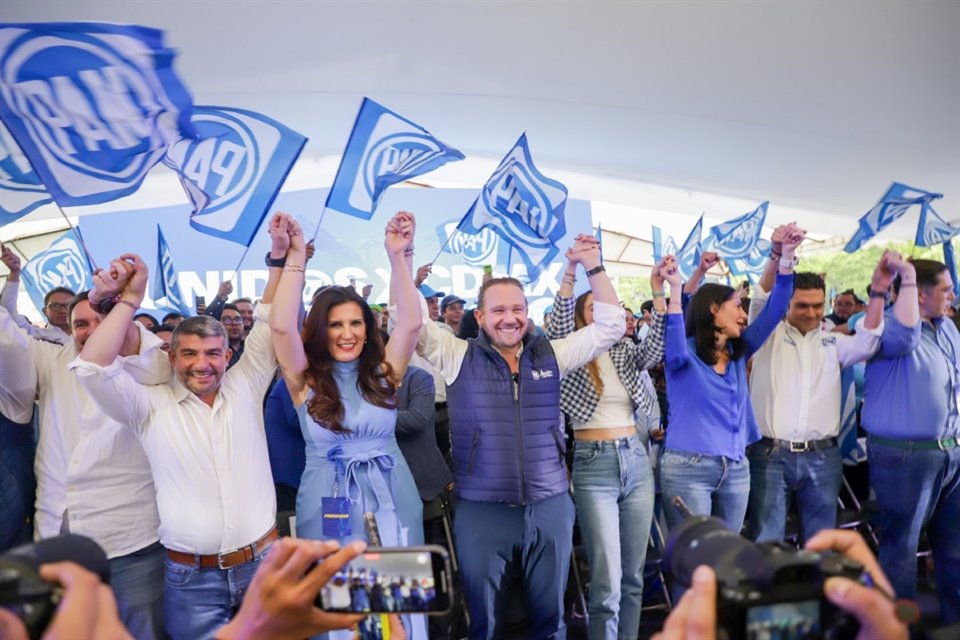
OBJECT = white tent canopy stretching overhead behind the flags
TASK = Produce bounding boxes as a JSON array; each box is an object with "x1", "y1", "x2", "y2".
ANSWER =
[{"x1": 0, "y1": 0, "x2": 960, "y2": 239}]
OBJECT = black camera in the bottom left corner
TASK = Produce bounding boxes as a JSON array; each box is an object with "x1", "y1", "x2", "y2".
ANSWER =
[{"x1": 0, "y1": 534, "x2": 110, "y2": 639}]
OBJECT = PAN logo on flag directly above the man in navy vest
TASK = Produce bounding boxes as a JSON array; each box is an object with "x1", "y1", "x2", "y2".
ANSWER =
[{"x1": 483, "y1": 160, "x2": 561, "y2": 246}]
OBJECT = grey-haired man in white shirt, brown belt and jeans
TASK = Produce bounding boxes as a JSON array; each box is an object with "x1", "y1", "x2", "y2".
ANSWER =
[{"x1": 71, "y1": 214, "x2": 290, "y2": 640}]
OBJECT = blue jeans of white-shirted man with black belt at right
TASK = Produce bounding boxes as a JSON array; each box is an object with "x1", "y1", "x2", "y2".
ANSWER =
[{"x1": 747, "y1": 442, "x2": 843, "y2": 542}]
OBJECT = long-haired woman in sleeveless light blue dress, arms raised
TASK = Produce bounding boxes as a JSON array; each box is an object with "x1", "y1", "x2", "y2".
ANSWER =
[{"x1": 270, "y1": 212, "x2": 426, "y2": 638}]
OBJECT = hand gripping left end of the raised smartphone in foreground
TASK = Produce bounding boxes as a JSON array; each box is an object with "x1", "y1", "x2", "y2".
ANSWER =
[{"x1": 216, "y1": 538, "x2": 365, "y2": 640}]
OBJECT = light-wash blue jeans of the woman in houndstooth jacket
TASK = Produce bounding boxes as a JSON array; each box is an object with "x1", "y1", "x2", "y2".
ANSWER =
[{"x1": 573, "y1": 436, "x2": 653, "y2": 640}]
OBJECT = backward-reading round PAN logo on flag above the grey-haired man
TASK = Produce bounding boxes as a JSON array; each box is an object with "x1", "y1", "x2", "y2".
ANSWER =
[{"x1": 173, "y1": 108, "x2": 255, "y2": 213}]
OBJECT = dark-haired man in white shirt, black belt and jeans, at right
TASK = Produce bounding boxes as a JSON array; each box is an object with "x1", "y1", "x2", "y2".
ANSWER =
[{"x1": 747, "y1": 250, "x2": 889, "y2": 542}]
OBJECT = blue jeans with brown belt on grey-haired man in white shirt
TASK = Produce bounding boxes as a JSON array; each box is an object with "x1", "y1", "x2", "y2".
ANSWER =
[{"x1": 163, "y1": 547, "x2": 269, "y2": 640}]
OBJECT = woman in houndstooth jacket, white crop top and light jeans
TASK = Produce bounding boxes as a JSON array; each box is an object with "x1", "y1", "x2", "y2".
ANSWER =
[{"x1": 546, "y1": 256, "x2": 679, "y2": 640}]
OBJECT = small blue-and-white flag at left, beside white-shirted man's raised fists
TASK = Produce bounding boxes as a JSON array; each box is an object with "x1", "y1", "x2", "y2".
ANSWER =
[{"x1": 20, "y1": 229, "x2": 93, "y2": 309}]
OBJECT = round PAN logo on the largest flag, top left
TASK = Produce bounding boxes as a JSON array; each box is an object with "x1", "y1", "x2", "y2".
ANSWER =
[{"x1": 0, "y1": 32, "x2": 176, "y2": 183}]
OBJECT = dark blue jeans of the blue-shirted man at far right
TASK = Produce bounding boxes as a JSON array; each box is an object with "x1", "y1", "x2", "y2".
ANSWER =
[{"x1": 867, "y1": 440, "x2": 960, "y2": 622}]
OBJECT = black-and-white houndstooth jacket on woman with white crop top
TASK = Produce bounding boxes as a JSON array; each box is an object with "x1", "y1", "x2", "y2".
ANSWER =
[{"x1": 546, "y1": 293, "x2": 667, "y2": 423}]
